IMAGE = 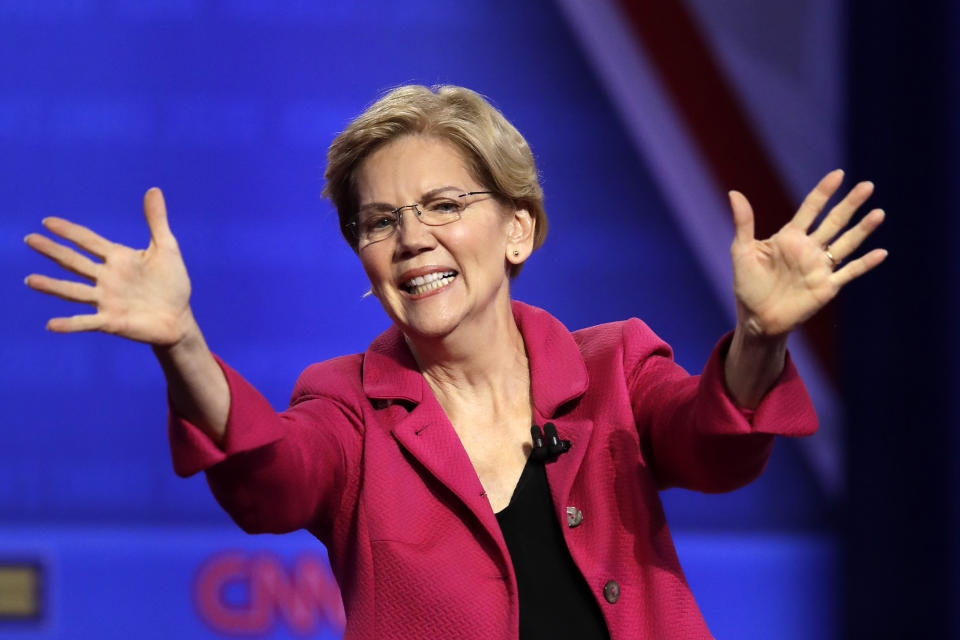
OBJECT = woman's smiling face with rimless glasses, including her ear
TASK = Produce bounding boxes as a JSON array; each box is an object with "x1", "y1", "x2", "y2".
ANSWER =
[{"x1": 357, "y1": 135, "x2": 532, "y2": 338}]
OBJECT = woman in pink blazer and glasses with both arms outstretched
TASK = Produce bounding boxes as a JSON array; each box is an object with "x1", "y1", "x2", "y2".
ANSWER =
[{"x1": 27, "y1": 86, "x2": 886, "y2": 639}]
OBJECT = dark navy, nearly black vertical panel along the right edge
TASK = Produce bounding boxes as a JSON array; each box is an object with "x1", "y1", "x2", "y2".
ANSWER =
[{"x1": 841, "y1": 0, "x2": 960, "y2": 638}]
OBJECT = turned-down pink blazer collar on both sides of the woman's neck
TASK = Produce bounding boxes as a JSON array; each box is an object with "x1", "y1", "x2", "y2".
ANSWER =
[{"x1": 363, "y1": 300, "x2": 588, "y2": 418}]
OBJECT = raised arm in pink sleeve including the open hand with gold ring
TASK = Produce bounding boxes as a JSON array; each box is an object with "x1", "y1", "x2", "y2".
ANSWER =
[{"x1": 624, "y1": 171, "x2": 887, "y2": 492}]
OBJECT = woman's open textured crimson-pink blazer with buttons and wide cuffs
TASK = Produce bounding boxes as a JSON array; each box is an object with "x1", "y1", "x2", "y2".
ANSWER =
[{"x1": 170, "y1": 302, "x2": 816, "y2": 640}]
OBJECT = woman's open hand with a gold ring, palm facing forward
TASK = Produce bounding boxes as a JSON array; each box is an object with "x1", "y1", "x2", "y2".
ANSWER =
[{"x1": 730, "y1": 169, "x2": 887, "y2": 337}]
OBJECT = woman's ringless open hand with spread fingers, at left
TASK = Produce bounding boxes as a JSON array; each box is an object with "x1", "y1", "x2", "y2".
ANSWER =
[{"x1": 25, "y1": 187, "x2": 199, "y2": 347}]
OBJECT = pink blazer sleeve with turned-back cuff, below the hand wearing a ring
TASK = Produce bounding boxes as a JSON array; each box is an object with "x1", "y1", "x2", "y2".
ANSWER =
[{"x1": 623, "y1": 319, "x2": 817, "y2": 492}]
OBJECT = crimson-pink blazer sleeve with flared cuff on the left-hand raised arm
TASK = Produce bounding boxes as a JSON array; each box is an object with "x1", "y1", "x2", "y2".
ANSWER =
[{"x1": 168, "y1": 356, "x2": 363, "y2": 533}]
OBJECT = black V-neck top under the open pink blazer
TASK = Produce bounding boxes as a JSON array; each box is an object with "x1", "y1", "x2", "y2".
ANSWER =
[{"x1": 497, "y1": 456, "x2": 610, "y2": 640}]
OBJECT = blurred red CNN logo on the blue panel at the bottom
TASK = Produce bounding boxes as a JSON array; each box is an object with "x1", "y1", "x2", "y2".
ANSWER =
[{"x1": 193, "y1": 551, "x2": 345, "y2": 637}]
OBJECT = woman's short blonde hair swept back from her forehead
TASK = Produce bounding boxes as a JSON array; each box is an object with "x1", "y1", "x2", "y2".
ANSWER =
[{"x1": 323, "y1": 85, "x2": 547, "y2": 277}]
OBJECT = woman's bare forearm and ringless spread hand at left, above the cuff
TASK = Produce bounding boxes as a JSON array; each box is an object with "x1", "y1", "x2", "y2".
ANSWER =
[{"x1": 25, "y1": 187, "x2": 230, "y2": 445}]
